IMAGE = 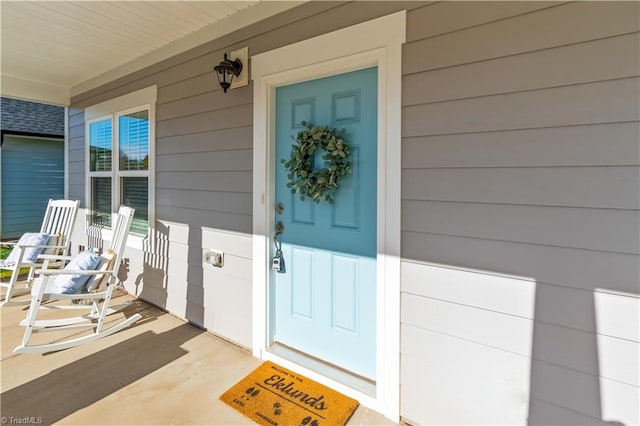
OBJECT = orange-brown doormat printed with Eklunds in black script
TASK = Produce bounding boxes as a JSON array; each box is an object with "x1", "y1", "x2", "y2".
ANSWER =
[{"x1": 220, "y1": 361, "x2": 358, "y2": 426}]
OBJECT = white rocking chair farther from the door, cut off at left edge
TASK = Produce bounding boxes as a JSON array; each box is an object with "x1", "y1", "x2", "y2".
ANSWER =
[{"x1": 0, "y1": 200, "x2": 80, "y2": 306}]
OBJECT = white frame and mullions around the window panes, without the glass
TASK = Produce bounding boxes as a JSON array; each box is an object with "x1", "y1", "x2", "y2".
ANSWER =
[{"x1": 84, "y1": 85, "x2": 158, "y2": 250}]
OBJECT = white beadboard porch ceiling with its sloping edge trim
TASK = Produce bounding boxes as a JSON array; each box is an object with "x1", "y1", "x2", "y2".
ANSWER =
[{"x1": 0, "y1": 0, "x2": 302, "y2": 105}]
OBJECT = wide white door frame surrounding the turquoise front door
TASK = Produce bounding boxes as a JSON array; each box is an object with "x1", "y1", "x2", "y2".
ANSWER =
[{"x1": 251, "y1": 11, "x2": 406, "y2": 421}]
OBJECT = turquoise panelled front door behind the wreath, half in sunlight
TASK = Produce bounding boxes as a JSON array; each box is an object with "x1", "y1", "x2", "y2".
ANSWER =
[{"x1": 271, "y1": 68, "x2": 378, "y2": 380}]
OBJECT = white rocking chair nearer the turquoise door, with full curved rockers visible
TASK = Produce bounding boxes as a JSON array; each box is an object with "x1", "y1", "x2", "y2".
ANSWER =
[{"x1": 13, "y1": 206, "x2": 141, "y2": 354}]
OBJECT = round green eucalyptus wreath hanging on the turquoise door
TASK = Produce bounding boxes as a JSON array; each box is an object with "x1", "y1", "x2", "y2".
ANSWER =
[{"x1": 280, "y1": 121, "x2": 351, "y2": 204}]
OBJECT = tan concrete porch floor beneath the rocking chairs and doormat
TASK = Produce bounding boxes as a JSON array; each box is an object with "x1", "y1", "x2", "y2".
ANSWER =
[{"x1": 0, "y1": 294, "x2": 394, "y2": 425}]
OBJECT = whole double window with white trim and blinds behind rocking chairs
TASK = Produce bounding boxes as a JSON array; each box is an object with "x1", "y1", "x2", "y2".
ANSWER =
[{"x1": 85, "y1": 86, "x2": 155, "y2": 236}]
